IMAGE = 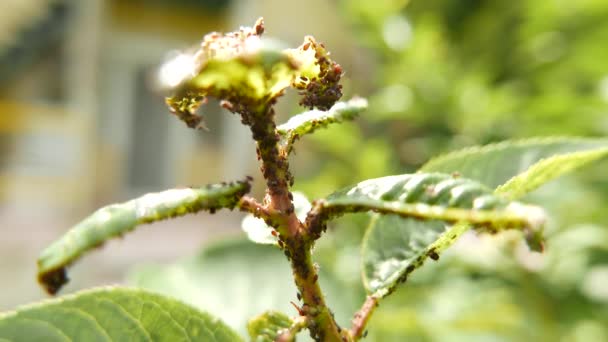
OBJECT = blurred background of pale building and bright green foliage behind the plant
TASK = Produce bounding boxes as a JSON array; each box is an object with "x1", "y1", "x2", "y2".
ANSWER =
[{"x1": 0, "y1": 0, "x2": 608, "y2": 341}]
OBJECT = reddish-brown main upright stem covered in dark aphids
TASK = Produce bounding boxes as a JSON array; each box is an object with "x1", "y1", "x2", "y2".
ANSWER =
[{"x1": 241, "y1": 104, "x2": 342, "y2": 341}]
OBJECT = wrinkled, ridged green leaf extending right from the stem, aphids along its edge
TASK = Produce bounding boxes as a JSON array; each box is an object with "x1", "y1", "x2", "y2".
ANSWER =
[{"x1": 316, "y1": 173, "x2": 544, "y2": 230}]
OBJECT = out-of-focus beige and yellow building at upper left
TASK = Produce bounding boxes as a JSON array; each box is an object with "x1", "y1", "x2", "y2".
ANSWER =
[{"x1": 0, "y1": 0, "x2": 256, "y2": 214}]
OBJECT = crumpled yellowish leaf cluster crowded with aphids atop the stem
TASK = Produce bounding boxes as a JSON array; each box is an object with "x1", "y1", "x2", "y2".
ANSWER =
[{"x1": 159, "y1": 18, "x2": 342, "y2": 127}]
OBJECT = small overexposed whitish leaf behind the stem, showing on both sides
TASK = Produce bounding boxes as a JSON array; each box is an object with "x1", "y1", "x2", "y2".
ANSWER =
[{"x1": 241, "y1": 191, "x2": 311, "y2": 246}]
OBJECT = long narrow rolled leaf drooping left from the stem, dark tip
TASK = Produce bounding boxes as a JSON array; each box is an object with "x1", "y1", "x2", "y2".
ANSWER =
[{"x1": 38, "y1": 181, "x2": 250, "y2": 294}]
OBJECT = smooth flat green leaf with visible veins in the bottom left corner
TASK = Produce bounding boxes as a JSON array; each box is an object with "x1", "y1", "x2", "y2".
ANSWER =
[{"x1": 0, "y1": 287, "x2": 242, "y2": 342}]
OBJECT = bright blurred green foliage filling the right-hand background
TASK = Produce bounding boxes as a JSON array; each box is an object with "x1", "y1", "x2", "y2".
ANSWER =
[{"x1": 288, "y1": 0, "x2": 608, "y2": 341}]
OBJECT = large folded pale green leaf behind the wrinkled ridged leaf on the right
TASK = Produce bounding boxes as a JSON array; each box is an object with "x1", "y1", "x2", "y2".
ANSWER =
[{"x1": 362, "y1": 138, "x2": 608, "y2": 295}]
